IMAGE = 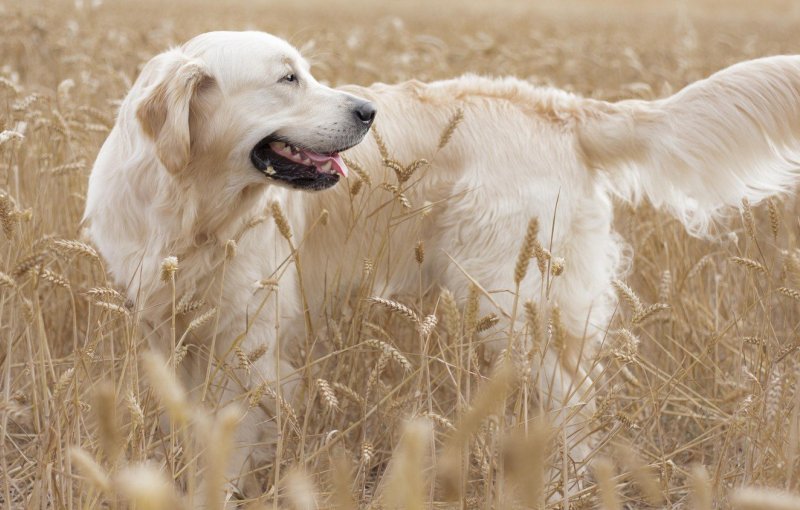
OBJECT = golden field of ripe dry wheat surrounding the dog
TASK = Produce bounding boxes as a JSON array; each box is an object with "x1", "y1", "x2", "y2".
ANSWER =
[{"x1": 0, "y1": 0, "x2": 800, "y2": 510}]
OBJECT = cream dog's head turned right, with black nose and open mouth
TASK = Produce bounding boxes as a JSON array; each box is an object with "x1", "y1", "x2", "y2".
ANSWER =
[{"x1": 135, "y1": 32, "x2": 376, "y2": 190}]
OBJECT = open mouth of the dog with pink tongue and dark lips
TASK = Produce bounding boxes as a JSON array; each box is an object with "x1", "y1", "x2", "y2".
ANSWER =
[{"x1": 250, "y1": 136, "x2": 347, "y2": 191}]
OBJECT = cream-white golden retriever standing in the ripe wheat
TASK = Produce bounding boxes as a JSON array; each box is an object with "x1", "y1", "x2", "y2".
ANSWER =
[{"x1": 85, "y1": 32, "x2": 800, "y2": 498}]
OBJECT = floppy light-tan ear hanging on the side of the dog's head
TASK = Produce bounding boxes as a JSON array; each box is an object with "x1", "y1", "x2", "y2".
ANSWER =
[{"x1": 136, "y1": 50, "x2": 214, "y2": 174}]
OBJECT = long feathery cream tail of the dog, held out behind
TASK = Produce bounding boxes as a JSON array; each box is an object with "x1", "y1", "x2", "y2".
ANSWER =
[{"x1": 577, "y1": 56, "x2": 800, "y2": 234}]
